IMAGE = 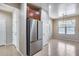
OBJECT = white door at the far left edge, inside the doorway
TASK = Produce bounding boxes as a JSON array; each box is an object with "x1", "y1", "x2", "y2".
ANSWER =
[{"x1": 0, "y1": 15, "x2": 6, "y2": 45}]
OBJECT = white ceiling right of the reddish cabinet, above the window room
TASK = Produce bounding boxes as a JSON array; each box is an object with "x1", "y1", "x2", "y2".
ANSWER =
[{"x1": 31, "y1": 3, "x2": 79, "y2": 18}]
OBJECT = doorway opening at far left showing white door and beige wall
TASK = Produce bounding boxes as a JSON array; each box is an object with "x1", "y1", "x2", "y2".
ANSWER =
[{"x1": 0, "y1": 10, "x2": 12, "y2": 45}]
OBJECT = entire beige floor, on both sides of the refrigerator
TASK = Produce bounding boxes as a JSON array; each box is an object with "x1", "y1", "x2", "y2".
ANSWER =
[{"x1": 0, "y1": 39, "x2": 79, "y2": 56}]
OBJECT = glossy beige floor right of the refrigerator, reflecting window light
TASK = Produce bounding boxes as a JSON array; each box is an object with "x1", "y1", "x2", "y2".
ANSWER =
[{"x1": 34, "y1": 39, "x2": 79, "y2": 56}]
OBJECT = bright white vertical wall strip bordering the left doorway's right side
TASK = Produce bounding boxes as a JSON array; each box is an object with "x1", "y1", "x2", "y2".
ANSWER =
[{"x1": 12, "y1": 10, "x2": 20, "y2": 49}]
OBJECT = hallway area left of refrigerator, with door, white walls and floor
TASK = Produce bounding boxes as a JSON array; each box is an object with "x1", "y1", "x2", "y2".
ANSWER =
[{"x1": 0, "y1": 3, "x2": 26, "y2": 56}]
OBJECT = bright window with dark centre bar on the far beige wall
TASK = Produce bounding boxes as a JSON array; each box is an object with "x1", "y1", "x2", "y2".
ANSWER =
[{"x1": 58, "y1": 20, "x2": 75, "y2": 34}]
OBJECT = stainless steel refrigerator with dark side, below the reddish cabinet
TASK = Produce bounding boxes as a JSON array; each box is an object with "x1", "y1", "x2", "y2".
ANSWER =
[{"x1": 26, "y1": 18, "x2": 42, "y2": 56}]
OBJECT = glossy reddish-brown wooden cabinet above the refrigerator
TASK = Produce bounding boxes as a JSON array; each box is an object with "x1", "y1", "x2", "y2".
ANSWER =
[{"x1": 27, "y1": 3, "x2": 41, "y2": 20}]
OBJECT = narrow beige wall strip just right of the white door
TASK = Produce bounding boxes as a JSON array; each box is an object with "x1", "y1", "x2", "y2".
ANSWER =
[{"x1": 6, "y1": 13, "x2": 12, "y2": 44}]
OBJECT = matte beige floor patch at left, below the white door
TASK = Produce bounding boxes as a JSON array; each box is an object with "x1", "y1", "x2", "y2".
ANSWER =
[{"x1": 0, "y1": 45, "x2": 21, "y2": 56}]
